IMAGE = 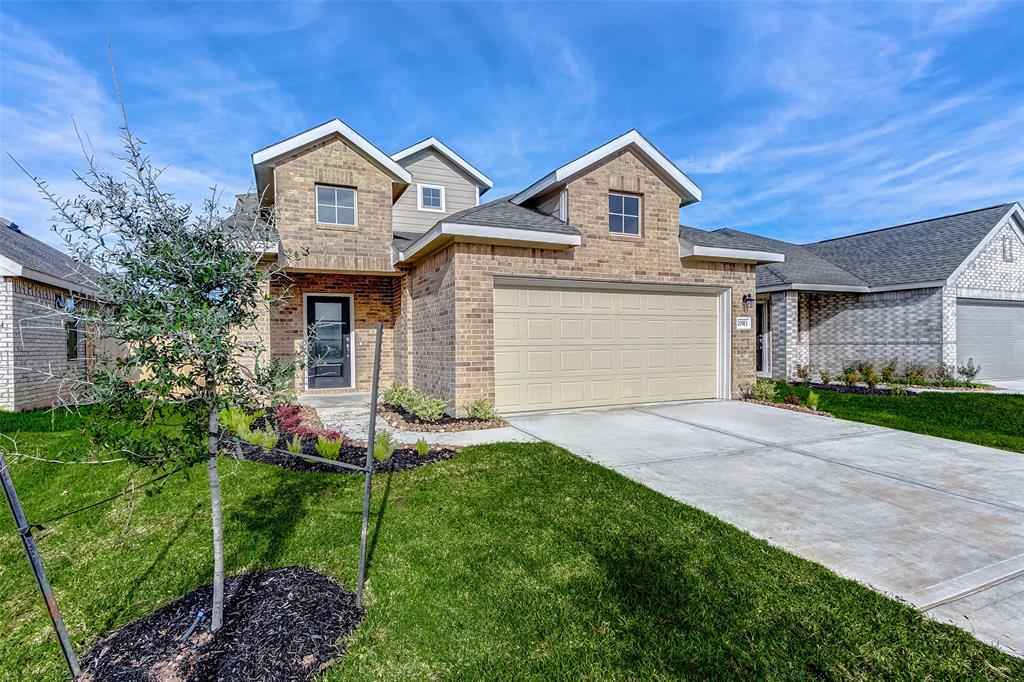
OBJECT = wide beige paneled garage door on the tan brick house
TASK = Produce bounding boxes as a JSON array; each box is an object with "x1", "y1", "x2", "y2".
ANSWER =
[{"x1": 495, "y1": 280, "x2": 718, "y2": 412}]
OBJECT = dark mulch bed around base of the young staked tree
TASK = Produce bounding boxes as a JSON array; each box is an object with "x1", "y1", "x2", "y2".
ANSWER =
[{"x1": 82, "y1": 566, "x2": 364, "y2": 682}]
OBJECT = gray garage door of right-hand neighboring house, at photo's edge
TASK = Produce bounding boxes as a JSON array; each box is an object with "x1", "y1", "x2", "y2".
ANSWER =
[{"x1": 956, "y1": 300, "x2": 1024, "y2": 380}]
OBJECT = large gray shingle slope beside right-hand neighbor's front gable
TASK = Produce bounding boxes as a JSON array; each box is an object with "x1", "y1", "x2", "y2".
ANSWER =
[{"x1": 804, "y1": 204, "x2": 1013, "y2": 287}]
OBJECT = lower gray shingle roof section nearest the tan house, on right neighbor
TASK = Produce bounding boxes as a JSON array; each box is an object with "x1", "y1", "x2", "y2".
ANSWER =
[{"x1": 679, "y1": 225, "x2": 866, "y2": 287}]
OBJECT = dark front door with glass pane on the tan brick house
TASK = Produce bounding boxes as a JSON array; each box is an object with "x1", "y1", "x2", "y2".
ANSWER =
[{"x1": 306, "y1": 296, "x2": 352, "y2": 388}]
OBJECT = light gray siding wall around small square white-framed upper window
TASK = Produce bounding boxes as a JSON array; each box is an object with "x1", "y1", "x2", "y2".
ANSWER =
[{"x1": 392, "y1": 147, "x2": 477, "y2": 232}]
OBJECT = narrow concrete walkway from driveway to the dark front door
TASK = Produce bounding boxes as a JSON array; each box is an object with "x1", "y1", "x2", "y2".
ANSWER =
[{"x1": 301, "y1": 393, "x2": 537, "y2": 445}]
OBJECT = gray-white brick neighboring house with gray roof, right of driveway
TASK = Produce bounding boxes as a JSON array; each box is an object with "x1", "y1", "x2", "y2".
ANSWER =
[{"x1": 683, "y1": 203, "x2": 1024, "y2": 380}]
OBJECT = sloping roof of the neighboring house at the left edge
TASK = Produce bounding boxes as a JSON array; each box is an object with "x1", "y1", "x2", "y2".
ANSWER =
[{"x1": 0, "y1": 218, "x2": 99, "y2": 294}]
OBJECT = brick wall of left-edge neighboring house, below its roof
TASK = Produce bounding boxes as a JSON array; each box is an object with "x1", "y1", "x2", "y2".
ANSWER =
[{"x1": 0, "y1": 278, "x2": 91, "y2": 410}]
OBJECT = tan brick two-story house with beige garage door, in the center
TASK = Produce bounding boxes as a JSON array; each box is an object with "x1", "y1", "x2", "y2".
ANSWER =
[{"x1": 239, "y1": 119, "x2": 782, "y2": 413}]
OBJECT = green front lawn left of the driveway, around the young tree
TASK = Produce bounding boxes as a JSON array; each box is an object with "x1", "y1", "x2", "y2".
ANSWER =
[{"x1": 0, "y1": 405, "x2": 1024, "y2": 680}]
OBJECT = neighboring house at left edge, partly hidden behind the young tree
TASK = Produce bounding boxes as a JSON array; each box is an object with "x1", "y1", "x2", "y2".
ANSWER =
[{"x1": 0, "y1": 218, "x2": 95, "y2": 410}]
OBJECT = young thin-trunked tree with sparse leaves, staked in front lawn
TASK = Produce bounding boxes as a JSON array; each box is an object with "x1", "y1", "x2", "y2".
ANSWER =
[{"x1": 20, "y1": 100, "x2": 302, "y2": 631}]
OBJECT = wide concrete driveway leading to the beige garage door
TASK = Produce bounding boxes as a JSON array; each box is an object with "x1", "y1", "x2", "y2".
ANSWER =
[{"x1": 508, "y1": 401, "x2": 1024, "y2": 655}]
